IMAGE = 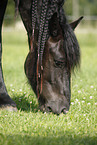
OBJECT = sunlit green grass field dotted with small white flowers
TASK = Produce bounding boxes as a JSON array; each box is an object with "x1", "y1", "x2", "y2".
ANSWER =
[{"x1": 0, "y1": 27, "x2": 97, "y2": 145}]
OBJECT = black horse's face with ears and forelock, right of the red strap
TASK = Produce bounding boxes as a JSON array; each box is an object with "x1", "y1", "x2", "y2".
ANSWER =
[{"x1": 39, "y1": 13, "x2": 82, "y2": 114}]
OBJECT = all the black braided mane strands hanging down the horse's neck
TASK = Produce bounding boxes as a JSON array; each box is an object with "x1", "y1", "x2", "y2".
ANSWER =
[{"x1": 32, "y1": 0, "x2": 64, "y2": 66}]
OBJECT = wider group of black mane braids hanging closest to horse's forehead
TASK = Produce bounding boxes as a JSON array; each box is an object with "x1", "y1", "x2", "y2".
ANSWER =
[{"x1": 38, "y1": 0, "x2": 64, "y2": 66}]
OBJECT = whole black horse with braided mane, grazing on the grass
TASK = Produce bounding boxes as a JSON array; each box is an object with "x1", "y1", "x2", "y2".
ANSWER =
[{"x1": 0, "y1": 0, "x2": 82, "y2": 114}]
